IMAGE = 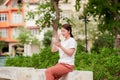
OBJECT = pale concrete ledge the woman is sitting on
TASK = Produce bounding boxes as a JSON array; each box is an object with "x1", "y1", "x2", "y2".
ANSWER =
[{"x1": 0, "y1": 67, "x2": 93, "y2": 80}]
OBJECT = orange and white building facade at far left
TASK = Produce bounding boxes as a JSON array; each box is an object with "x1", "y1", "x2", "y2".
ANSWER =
[{"x1": 0, "y1": 0, "x2": 24, "y2": 56}]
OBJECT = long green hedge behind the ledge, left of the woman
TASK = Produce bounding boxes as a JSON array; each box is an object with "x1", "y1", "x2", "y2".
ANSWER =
[{"x1": 5, "y1": 47, "x2": 59, "y2": 68}]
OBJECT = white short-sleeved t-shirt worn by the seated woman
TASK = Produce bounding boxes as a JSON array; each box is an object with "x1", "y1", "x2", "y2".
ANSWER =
[{"x1": 58, "y1": 37, "x2": 77, "y2": 65}]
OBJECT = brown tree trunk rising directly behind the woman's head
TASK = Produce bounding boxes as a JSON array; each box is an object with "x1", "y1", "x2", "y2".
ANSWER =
[{"x1": 51, "y1": 0, "x2": 60, "y2": 36}]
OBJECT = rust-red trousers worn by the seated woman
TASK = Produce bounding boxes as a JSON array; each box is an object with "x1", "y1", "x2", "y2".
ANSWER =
[{"x1": 45, "y1": 63, "x2": 74, "y2": 80}]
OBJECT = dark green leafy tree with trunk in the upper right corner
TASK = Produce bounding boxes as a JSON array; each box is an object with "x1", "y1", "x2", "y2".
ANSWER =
[{"x1": 79, "y1": 0, "x2": 120, "y2": 48}]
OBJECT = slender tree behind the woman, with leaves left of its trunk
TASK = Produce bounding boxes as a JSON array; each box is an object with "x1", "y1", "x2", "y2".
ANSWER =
[{"x1": 27, "y1": 0, "x2": 60, "y2": 34}]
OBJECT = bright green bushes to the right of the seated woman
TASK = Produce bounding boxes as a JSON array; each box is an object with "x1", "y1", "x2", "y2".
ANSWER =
[{"x1": 75, "y1": 48, "x2": 120, "y2": 80}]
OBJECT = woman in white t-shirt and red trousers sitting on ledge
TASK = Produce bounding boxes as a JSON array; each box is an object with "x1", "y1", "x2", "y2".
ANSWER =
[{"x1": 45, "y1": 24, "x2": 77, "y2": 80}]
